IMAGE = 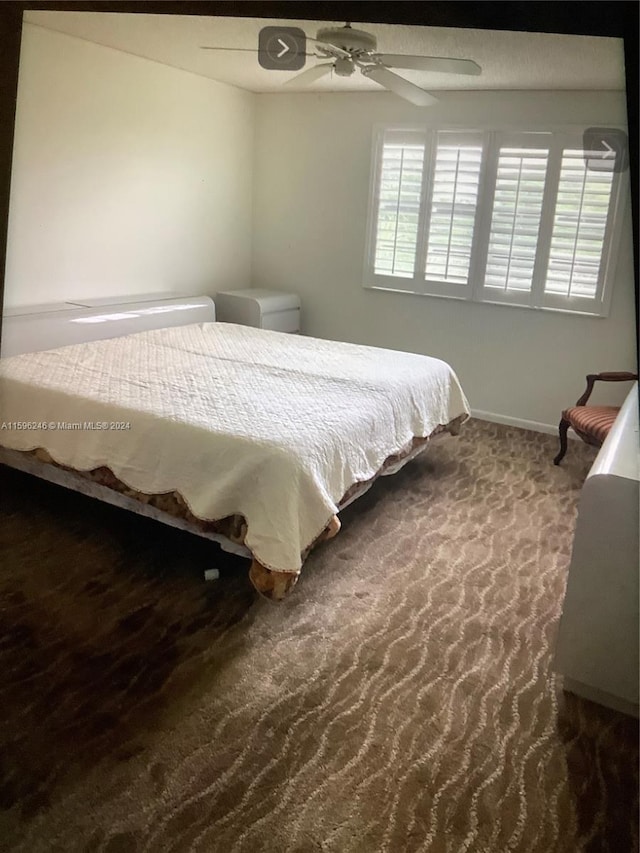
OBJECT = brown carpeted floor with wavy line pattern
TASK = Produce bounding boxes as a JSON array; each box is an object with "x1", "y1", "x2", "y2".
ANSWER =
[{"x1": 0, "y1": 421, "x2": 638, "y2": 853}]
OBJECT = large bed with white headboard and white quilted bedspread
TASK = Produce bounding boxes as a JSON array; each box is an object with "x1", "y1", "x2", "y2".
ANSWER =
[{"x1": 0, "y1": 296, "x2": 469, "y2": 600}]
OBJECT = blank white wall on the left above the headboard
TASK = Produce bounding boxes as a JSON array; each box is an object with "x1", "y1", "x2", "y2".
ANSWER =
[{"x1": 5, "y1": 24, "x2": 254, "y2": 307}]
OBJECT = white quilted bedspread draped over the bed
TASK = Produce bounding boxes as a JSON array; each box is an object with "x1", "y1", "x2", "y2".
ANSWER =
[{"x1": 0, "y1": 323, "x2": 468, "y2": 571}]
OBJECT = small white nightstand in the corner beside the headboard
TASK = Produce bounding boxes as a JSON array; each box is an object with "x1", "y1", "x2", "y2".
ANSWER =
[{"x1": 215, "y1": 288, "x2": 300, "y2": 332}]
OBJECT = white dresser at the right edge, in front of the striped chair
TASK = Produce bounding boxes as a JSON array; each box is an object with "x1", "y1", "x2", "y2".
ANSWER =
[{"x1": 555, "y1": 384, "x2": 640, "y2": 716}]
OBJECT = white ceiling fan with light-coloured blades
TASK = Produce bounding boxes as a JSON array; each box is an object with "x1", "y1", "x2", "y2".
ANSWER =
[{"x1": 204, "y1": 23, "x2": 482, "y2": 107}]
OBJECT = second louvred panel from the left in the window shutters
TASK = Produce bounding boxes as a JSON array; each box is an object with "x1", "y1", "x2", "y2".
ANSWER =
[{"x1": 425, "y1": 132, "x2": 482, "y2": 285}]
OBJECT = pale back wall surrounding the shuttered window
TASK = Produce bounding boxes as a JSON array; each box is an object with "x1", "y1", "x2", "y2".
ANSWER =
[{"x1": 252, "y1": 92, "x2": 636, "y2": 430}]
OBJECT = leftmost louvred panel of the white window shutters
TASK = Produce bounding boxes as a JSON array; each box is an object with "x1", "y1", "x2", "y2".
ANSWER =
[{"x1": 374, "y1": 133, "x2": 425, "y2": 278}]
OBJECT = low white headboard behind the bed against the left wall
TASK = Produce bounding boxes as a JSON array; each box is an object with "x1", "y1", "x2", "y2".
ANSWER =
[{"x1": 0, "y1": 294, "x2": 216, "y2": 356}]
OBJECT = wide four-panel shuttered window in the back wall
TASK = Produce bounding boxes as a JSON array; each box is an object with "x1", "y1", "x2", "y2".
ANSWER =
[{"x1": 365, "y1": 129, "x2": 622, "y2": 316}]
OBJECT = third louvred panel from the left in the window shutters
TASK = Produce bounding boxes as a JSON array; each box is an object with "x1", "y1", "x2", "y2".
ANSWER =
[{"x1": 484, "y1": 146, "x2": 549, "y2": 295}]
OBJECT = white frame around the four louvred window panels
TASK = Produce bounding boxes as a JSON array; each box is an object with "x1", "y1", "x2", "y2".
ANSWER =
[{"x1": 362, "y1": 123, "x2": 629, "y2": 317}]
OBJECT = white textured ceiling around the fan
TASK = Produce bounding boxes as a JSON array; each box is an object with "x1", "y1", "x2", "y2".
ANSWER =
[{"x1": 25, "y1": 11, "x2": 625, "y2": 92}]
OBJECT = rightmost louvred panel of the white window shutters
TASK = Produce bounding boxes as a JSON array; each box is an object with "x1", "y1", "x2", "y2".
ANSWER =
[{"x1": 544, "y1": 148, "x2": 614, "y2": 299}]
